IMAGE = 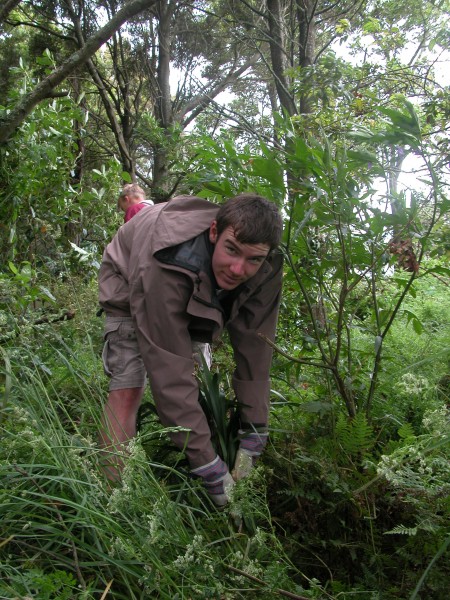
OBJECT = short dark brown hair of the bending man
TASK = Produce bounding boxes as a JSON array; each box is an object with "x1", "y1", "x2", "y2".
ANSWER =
[{"x1": 216, "y1": 194, "x2": 283, "y2": 250}]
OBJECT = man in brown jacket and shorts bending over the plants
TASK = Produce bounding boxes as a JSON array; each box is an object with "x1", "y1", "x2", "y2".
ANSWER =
[{"x1": 99, "y1": 194, "x2": 283, "y2": 506}]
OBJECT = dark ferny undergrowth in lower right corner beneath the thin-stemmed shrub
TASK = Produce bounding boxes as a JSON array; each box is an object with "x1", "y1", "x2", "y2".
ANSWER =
[{"x1": 267, "y1": 392, "x2": 450, "y2": 599}]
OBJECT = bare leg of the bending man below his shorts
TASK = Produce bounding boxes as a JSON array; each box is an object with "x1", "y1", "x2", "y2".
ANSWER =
[{"x1": 100, "y1": 387, "x2": 145, "y2": 481}]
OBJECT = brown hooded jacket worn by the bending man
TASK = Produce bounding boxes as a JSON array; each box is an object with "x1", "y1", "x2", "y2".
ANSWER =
[{"x1": 99, "y1": 196, "x2": 282, "y2": 468}]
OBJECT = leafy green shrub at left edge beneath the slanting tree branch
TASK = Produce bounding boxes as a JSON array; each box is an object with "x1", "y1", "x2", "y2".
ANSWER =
[{"x1": 0, "y1": 53, "x2": 121, "y2": 276}]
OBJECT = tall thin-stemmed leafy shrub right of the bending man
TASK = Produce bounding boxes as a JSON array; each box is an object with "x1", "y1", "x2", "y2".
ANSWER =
[{"x1": 185, "y1": 98, "x2": 445, "y2": 432}]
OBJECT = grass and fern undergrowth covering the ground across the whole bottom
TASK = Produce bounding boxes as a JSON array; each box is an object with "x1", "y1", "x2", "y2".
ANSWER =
[{"x1": 0, "y1": 276, "x2": 450, "y2": 600}]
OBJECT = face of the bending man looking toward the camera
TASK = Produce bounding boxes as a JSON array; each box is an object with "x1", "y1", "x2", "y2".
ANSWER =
[{"x1": 209, "y1": 221, "x2": 270, "y2": 290}]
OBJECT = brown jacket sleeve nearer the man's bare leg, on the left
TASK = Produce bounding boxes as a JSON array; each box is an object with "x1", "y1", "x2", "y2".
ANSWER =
[{"x1": 130, "y1": 261, "x2": 215, "y2": 468}]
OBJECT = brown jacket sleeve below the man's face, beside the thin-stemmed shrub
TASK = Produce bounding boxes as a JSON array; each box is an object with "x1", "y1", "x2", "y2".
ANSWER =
[{"x1": 227, "y1": 254, "x2": 283, "y2": 425}]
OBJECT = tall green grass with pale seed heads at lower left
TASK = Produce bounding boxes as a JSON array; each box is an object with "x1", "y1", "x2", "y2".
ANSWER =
[{"x1": 0, "y1": 338, "x2": 306, "y2": 600}]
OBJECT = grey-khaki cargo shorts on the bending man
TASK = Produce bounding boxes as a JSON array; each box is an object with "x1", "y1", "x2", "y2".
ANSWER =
[{"x1": 102, "y1": 315, "x2": 147, "y2": 391}]
